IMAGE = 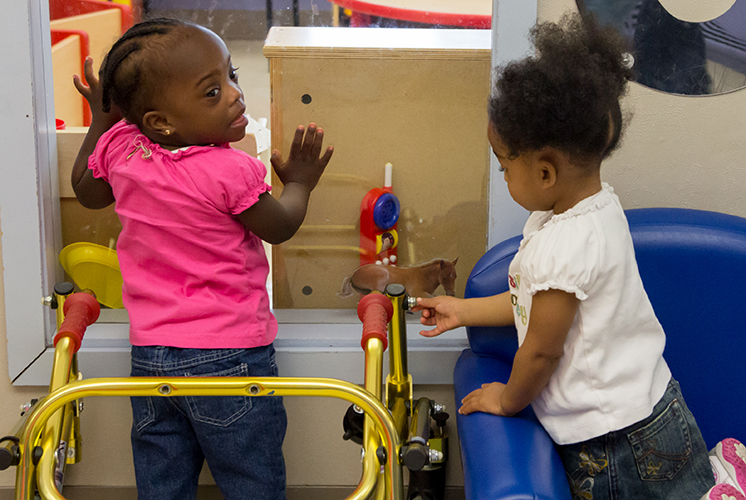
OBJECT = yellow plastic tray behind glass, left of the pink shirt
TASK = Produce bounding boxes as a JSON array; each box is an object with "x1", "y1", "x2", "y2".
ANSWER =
[{"x1": 60, "y1": 242, "x2": 124, "y2": 309}]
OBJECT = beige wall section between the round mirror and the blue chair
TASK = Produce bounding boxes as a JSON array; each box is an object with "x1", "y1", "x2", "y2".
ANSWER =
[{"x1": 538, "y1": 0, "x2": 746, "y2": 217}]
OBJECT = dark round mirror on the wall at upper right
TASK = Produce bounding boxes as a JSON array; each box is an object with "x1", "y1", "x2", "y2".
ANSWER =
[{"x1": 577, "y1": 0, "x2": 746, "y2": 95}]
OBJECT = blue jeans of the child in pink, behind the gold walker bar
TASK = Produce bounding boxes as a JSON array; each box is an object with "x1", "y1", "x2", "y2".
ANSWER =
[{"x1": 131, "y1": 345, "x2": 287, "y2": 500}]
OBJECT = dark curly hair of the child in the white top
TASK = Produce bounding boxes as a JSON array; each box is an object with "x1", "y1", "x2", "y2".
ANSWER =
[{"x1": 489, "y1": 14, "x2": 633, "y2": 164}]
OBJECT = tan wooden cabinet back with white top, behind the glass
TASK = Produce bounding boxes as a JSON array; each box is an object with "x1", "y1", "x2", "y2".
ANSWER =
[{"x1": 265, "y1": 28, "x2": 490, "y2": 309}]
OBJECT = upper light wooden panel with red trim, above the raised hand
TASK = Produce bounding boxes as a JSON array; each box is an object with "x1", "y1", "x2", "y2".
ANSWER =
[{"x1": 49, "y1": 9, "x2": 122, "y2": 72}]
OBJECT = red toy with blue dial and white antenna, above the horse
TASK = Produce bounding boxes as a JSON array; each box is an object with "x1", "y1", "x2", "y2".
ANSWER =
[{"x1": 360, "y1": 163, "x2": 401, "y2": 265}]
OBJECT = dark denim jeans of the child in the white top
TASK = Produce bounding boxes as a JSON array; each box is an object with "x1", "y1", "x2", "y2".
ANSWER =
[{"x1": 557, "y1": 379, "x2": 715, "y2": 500}]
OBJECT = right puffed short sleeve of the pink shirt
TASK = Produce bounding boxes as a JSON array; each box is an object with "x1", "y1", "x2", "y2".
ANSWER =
[{"x1": 185, "y1": 147, "x2": 272, "y2": 215}]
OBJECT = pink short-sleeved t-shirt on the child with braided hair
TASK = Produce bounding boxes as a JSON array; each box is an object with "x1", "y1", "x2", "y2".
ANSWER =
[{"x1": 88, "y1": 120, "x2": 277, "y2": 348}]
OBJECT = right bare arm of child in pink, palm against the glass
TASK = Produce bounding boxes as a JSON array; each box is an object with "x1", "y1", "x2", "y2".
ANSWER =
[{"x1": 239, "y1": 123, "x2": 334, "y2": 245}]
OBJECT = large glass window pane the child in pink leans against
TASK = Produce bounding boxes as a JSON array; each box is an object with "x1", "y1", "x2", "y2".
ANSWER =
[{"x1": 50, "y1": 0, "x2": 492, "y2": 309}]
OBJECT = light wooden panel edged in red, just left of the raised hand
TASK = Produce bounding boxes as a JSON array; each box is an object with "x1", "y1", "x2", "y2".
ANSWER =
[{"x1": 52, "y1": 35, "x2": 83, "y2": 127}]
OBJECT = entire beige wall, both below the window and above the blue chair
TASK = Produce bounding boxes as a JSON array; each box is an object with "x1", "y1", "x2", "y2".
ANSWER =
[{"x1": 0, "y1": 0, "x2": 746, "y2": 487}]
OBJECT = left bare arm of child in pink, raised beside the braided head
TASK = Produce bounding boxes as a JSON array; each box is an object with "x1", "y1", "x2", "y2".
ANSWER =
[{"x1": 70, "y1": 57, "x2": 121, "y2": 208}]
